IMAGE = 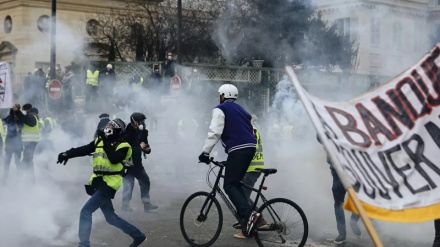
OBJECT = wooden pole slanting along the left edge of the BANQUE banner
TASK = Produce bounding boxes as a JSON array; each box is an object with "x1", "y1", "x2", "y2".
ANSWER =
[{"x1": 286, "y1": 66, "x2": 383, "y2": 247}]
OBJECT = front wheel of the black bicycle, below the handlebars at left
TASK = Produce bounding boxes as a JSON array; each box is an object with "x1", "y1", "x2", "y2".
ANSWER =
[{"x1": 180, "y1": 191, "x2": 223, "y2": 247}]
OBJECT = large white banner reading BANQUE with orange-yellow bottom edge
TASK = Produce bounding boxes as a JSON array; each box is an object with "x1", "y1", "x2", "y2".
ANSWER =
[{"x1": 288, "y1": 45, "x2": 440, "y2": 222}]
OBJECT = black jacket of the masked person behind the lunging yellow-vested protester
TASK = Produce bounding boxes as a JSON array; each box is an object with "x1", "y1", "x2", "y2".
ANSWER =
[{"x1": 125, "y1": 124, "x2": 149, "y2": 166}]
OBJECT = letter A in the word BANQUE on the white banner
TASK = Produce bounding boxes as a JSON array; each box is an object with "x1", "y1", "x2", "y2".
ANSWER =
[{"x1": 356, "y1": 104, "x2": 395, "y2": 146}]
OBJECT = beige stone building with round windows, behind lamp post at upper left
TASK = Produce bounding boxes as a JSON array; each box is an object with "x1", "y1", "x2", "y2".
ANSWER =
[{"x1": 0, "y1": 0, "x2": 121, "y2": 74}]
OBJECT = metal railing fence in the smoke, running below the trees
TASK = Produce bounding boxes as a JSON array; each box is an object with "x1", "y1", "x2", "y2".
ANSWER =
[{"x1": 13, "y1": 62, "x2": 388, "y2": 115}]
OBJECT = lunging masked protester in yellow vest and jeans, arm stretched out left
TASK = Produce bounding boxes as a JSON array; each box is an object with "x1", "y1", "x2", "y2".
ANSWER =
[{"x1": 57, "y1": 118, "x2": 147, "y2": 247}]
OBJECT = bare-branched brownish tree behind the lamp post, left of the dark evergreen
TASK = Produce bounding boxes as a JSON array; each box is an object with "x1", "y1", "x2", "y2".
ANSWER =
[{"x1": 87, "y1": 0, "x2": 224, "y2": 61}]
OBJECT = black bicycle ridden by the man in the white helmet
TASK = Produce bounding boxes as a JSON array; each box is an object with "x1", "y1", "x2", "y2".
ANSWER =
[{"x1": 180, "y1": 160, "x2": 308, "y2": 247}]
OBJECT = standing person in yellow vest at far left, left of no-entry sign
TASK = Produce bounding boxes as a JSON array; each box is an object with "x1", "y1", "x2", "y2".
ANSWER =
[{"x1": 16, "y1": 103, "x2": 40, "y2": 183}]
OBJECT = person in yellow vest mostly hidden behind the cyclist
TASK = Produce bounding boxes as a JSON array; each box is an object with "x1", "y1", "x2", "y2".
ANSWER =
[{"x1": 234, "y1": 115, "x2": 267, "y2": 239}]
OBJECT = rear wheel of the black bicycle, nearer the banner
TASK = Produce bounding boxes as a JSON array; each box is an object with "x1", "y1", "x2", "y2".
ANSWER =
[{"x1": 255, "y1": 198, "x2": 309, "y2": 247}]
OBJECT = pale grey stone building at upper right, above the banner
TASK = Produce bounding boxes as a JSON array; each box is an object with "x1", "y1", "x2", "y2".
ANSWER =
[{"x1": 315, "y1": 0, "x2": 440, "y2": 76}]
